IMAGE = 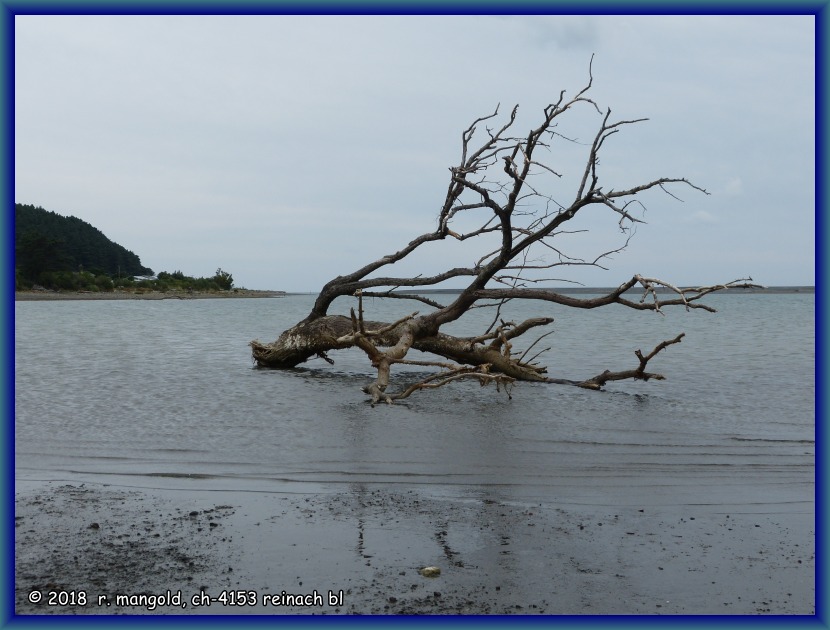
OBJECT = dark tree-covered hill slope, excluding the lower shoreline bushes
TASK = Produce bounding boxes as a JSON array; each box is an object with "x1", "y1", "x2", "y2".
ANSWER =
[{"x1": 14, "y1": 203, "x2": 153, "y2": 287}]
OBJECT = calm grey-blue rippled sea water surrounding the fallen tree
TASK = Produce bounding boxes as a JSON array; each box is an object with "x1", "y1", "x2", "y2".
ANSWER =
[{"x1": 15, "y1": 294, "x2": 815, "y2": 511}]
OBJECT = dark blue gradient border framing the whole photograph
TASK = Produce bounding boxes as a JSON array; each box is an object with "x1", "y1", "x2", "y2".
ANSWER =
[{"x1": 0, "y1": 0, "x2": 830, "y2": 627}]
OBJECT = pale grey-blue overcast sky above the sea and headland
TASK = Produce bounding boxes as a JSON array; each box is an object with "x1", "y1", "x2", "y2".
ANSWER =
[{"x1": 15, "y1": 15, "x2": 815, "y2": 291}]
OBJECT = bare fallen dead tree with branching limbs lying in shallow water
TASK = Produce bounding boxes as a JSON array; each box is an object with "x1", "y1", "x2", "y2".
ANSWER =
[{"x1": 251, "y1": 63, "x2": 756, "y2": 405}]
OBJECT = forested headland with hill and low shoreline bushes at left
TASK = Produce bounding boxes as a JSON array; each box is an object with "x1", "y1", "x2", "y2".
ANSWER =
[{"x1": 14, "y1": 203, "x2": 233, "y2": 292}]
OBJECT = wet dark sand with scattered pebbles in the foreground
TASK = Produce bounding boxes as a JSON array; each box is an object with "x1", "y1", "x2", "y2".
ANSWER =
[{"x1": 15, "y1": 478, "x2": 815, "y2": 615}]
